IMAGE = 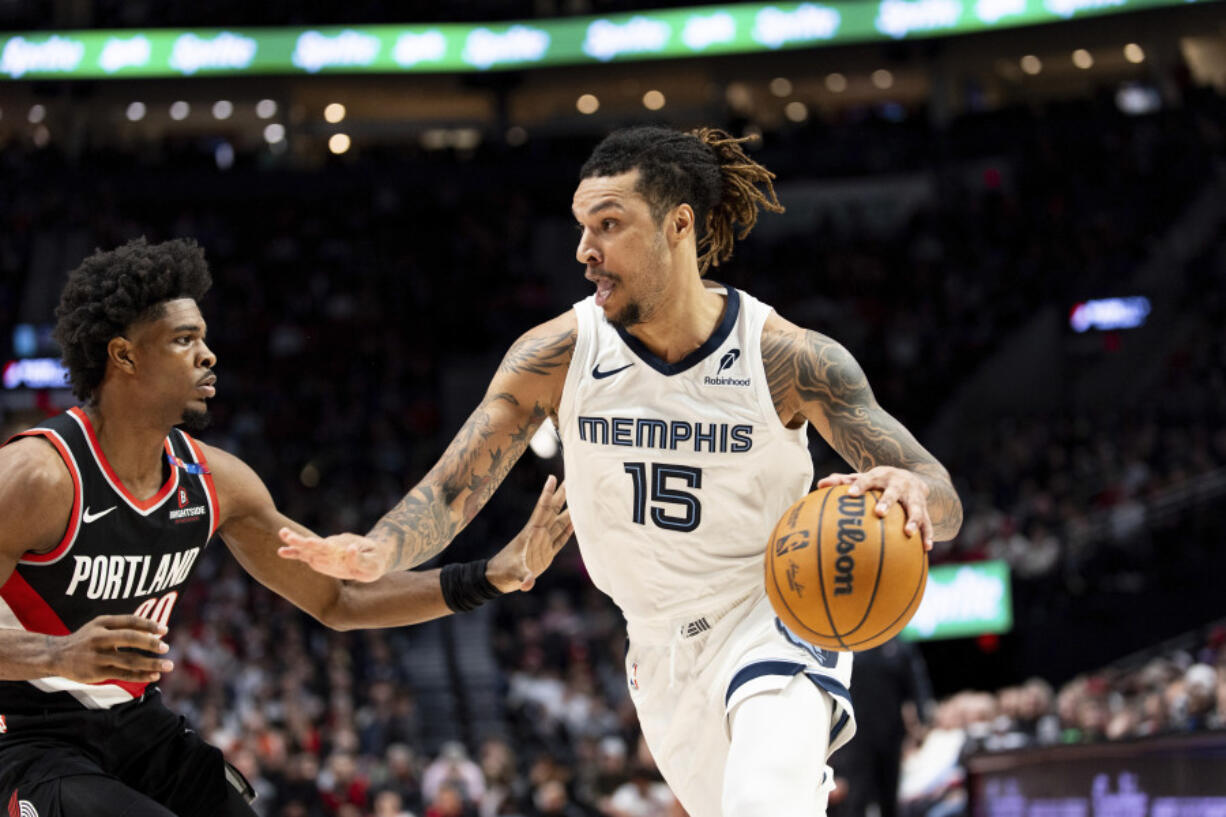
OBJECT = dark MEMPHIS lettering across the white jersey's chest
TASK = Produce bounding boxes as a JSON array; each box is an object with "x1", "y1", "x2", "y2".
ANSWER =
[{"x1": 579, "y1": 416, "x2": 754, "y2": 454}]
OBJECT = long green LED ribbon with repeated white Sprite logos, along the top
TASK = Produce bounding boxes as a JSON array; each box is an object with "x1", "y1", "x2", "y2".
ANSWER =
[{"x1": 0, "y1": 0, "x2": 1204, "y2": 80}]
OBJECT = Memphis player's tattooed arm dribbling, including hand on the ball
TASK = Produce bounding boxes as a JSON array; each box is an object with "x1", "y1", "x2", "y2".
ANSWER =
[{"x1": 763, "y1": 315, "x2": 962, "y2": 546}]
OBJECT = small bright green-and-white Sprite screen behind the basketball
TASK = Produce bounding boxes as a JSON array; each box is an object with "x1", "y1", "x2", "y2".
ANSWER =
[{"x1": 901, "y1": 562, "x2": 1013, "y2": 642}]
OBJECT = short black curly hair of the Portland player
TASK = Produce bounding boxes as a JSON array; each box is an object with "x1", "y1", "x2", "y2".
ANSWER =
[{"x1": 54, "y1": 237, "x2": 212, "y2": 401}]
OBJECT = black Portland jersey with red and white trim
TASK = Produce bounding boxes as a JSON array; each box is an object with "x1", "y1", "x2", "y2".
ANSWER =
[{"x1": 0, "y1": 409, "x2": 217, "y2": 713}]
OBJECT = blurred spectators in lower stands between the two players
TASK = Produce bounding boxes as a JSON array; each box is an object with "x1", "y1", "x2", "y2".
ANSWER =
[{"x1": 150, "y1": 548, "x2": 678, "y2": 817}]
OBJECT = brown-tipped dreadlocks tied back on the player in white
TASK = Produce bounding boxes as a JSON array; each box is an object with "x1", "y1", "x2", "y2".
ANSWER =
[{"x1": 579, "y1": 125, "x2": 783, "y2": 275}]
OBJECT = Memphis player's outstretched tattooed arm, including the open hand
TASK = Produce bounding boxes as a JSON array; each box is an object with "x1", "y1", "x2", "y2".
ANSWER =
[{"x1": 282, "y1": 306, "x2": 577, "y2": 581}]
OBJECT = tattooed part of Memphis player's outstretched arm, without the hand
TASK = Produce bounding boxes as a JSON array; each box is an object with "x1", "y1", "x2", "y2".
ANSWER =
[{"x1": 369, "y1": 330, "x2": 575, "y2": 569}]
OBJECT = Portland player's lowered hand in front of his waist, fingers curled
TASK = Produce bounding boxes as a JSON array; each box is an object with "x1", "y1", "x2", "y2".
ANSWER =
[{"x1": 48, "y1": 616, "x2": 174, "y2": 683}]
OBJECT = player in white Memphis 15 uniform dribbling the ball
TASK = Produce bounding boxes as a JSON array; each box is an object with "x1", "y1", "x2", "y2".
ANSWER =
[{"x1": 282, "y1": 128, "x2": 961, "y2": 817}]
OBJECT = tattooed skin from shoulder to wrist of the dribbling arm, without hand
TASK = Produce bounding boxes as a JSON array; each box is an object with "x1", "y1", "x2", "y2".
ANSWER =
[{"x1": 763, "y1": 323, "x2": 962, "y2": 539}]
